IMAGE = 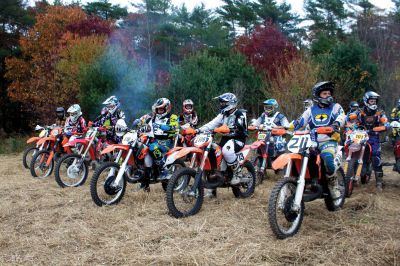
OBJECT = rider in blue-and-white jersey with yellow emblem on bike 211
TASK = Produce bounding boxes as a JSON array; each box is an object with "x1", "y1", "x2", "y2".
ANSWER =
[{"x1": 293, "y1": 81, "x2": 346, "y2": 199}]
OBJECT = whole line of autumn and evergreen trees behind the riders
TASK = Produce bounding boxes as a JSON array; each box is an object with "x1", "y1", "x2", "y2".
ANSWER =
[{"x1": 0, "y1": 0, "x2": 400, "y2": 135}]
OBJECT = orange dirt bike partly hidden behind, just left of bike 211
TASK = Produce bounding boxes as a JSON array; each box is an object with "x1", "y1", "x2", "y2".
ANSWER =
[{"x1": 248, "y1": 125, "x2": 286, "y2": 185}]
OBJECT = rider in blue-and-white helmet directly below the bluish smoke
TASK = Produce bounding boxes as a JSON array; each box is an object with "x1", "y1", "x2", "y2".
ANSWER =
[{"x1": 93, "y1": 95, "x2": 125, "y2": 143}]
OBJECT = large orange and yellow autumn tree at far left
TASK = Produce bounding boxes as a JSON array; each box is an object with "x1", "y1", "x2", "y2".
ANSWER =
[{"x1": 6, "y1": 6, "x2": 111, "y2": 116}]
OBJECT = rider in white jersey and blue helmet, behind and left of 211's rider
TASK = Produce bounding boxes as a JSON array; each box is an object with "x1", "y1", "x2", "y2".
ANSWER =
[{"x1": 252, "y1": 99, "x2": 289, "y2": 162}]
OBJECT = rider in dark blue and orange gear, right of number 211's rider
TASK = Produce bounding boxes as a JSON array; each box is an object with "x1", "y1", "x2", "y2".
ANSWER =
[{"x1": 358, "y1": 91, "x2": 389, "y2": 191}]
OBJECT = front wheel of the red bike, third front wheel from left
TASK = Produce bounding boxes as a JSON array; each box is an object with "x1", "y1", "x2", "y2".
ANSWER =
[{"x1": 54, "y1": 153, "x2": 89, "y2": 188}]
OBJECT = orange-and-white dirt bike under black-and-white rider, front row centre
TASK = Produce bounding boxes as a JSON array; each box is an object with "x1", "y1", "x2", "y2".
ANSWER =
[{"x1": 166, "y1": 126, "x2": 256, "y2": 218}]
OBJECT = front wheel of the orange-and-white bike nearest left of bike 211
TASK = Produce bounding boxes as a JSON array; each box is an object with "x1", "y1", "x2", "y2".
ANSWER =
[{"x1": 166, "y1": 168, "x2": 204, "y2": 218}]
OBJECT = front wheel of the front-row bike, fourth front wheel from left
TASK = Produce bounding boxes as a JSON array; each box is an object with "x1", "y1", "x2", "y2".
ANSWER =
[{"x1": 90, "y1": 162, "x2": 126, "y2": 206}]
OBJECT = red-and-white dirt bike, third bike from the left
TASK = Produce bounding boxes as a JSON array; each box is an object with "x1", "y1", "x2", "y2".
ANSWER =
[{"x1": 54, "y1": 127, "x2": 111, "y2": 188}]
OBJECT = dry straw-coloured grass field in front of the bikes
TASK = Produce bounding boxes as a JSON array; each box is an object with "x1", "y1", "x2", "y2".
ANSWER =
[{"x1": 0, "y1": 155, "x2": 400, "y2": 265}]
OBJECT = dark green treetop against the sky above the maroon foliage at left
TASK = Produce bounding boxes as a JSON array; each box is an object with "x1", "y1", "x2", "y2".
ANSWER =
[{"x1": 83, "y1": 0, "x2": 128, "y2": 20}]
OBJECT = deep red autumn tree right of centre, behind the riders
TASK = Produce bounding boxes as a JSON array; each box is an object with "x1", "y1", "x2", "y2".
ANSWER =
[{"x1": 235, "y1": 23, "x2": 298, "y2": 80}]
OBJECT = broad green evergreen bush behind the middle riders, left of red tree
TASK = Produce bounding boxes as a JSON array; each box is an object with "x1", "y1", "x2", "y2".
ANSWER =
[{"x1": 166, "y1": 51, "x2": 262, "y2": 122}]
